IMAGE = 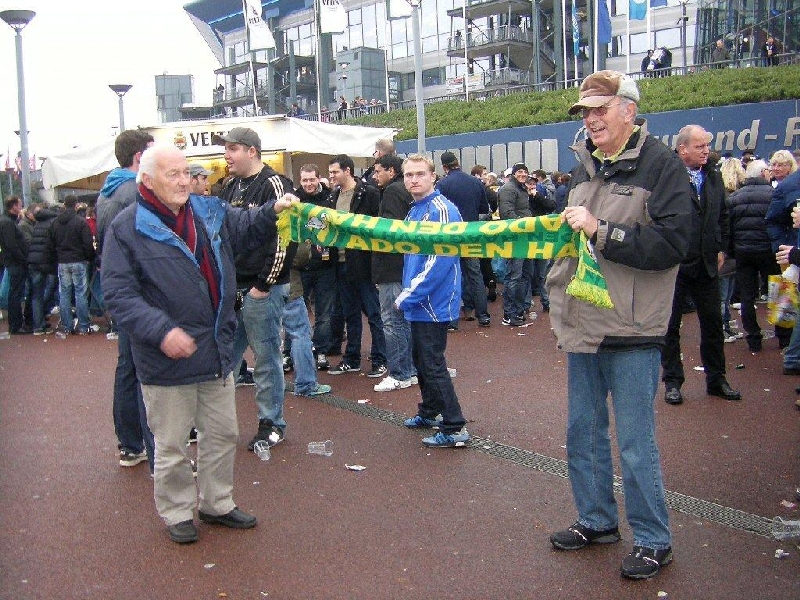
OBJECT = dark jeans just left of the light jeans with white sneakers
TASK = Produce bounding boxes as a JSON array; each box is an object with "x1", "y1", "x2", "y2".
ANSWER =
[{"x1": 336, "y1": 263, "x2": 386, "y2": 366}]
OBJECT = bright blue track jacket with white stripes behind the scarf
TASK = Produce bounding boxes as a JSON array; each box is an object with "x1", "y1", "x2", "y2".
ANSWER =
[{"x1": 395, "y1": 190, "x2": 462, "y2": 323}]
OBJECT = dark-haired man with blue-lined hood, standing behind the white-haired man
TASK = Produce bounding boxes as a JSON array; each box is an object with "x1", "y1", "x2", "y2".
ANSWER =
[{"x1": 97, "y1": 129, "x2": 154, "y2": 473}]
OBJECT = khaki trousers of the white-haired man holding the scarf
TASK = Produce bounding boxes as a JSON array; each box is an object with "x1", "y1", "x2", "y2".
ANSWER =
[{"x1": 142, "y1": 375, "x2": 239, "y2": 525}]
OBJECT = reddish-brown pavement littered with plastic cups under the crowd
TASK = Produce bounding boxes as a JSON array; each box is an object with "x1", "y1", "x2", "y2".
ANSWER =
[{"x1": 0, "y1": 300, "x2": 800, "y2": 600}]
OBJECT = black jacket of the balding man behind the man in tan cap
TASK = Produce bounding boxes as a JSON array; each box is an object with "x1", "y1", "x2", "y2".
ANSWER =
[{"x1": 679, "y1": 164, "x2": 730, "y2": 277}]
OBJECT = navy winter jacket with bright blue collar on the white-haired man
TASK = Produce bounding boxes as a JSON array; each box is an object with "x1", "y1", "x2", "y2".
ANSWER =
[{"x1": 101, "y1": 195, "x2": 276, "y2": 386}]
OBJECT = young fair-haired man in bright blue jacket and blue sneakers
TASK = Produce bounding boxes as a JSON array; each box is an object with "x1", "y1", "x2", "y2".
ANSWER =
[{"x1": 395, "y1": 154, "x2": 469, "y2": 448}]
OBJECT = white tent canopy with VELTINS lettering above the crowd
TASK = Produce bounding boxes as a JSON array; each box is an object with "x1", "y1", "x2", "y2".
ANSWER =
[{"x1": 42, "y1": 115, "x2": 397, "y2": 189}]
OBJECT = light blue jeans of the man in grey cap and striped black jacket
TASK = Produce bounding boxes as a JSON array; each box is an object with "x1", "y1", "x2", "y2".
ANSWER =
[{"x1": 241, "y1": 283, "x2": 289, "y2": 429}]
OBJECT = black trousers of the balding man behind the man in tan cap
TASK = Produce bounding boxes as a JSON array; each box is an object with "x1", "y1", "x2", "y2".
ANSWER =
[{"x1": 661, "y1": 273, "x2": 725, "y2": 388}]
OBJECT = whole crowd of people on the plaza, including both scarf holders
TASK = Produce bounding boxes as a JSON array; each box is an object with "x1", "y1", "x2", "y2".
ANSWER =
[{"x1": 0, "y1": 71, "x2": 800, "y2": 579}]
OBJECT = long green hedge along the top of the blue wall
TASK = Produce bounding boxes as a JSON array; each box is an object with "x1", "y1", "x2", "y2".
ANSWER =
[{"x1": 346, "y1": 65, "x2": 800, "y2": 140}]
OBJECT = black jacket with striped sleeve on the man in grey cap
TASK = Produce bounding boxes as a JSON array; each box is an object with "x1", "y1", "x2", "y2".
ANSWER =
[{"x1": 220, "y1": 165, "x2": 295, "y2": 292}]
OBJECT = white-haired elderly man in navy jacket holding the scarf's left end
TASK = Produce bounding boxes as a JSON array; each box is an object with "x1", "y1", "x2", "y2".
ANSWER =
[{"x1": 102, "y1": 146, "x2": 286, "y2": 543}]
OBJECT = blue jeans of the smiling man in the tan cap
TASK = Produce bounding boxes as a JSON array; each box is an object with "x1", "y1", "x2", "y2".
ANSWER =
[{"x1": 567, "y1": 348, "x2": 671, "y2": 550}]
